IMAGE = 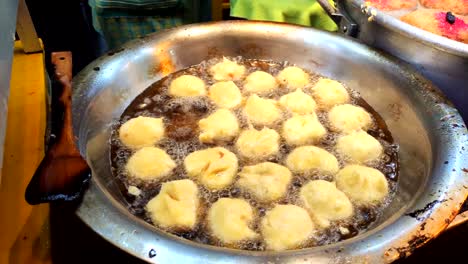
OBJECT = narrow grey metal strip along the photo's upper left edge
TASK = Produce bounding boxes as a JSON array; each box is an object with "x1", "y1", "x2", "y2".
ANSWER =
[{"x1": 0, "y1": 0, "x2": 18, "y2": 183}]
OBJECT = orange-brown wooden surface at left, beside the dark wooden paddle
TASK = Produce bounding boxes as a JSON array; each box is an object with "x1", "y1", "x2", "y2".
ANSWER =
[{"x1": 0, "y1": 42, "x2": 51, "y2": 264}]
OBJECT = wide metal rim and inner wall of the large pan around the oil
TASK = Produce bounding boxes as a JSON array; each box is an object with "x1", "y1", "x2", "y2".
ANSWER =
[{"x1": 73, "y1": 21, "x2": 468, "y2": 263}]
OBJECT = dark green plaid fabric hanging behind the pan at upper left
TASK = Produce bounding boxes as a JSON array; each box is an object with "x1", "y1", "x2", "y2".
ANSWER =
[{"x1": 89, "y1": 0, "x2": 183, "y2": 49}]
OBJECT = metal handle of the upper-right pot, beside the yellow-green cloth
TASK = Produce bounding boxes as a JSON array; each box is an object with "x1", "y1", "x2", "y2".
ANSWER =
[{"x1": 317, "y1": 0, "x2": 359, "y2": 37}]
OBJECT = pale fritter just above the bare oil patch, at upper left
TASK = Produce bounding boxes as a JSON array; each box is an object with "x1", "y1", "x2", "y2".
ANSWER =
[{"x1": 169, "y1": 75, "x2": 206, "y2": 97}]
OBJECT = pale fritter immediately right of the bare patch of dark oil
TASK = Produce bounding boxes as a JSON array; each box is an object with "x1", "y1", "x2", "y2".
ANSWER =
[{"x1": 198, "y1": 109, "x2": 239, "y2": 143}]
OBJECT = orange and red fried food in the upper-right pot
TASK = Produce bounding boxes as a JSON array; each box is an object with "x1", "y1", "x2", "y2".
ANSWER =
[{"x1": 400, "y1": 9, "x2": 468, "y2": 44}]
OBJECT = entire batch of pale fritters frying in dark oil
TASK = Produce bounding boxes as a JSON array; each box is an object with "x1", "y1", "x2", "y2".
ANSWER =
[{"x1": 118, "y1": 58, "x2": 389, "y2": 250}]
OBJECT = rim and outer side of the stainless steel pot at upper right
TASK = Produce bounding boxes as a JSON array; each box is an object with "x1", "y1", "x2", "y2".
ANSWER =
[{"x1": 318, "y1": 0, "x2": 468, "y2": 121}]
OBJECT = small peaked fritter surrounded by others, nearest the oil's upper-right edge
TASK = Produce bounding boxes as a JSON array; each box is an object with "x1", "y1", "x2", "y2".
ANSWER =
[{"x1": 279, "y1": 89, "x2": 317, "y2": 114}]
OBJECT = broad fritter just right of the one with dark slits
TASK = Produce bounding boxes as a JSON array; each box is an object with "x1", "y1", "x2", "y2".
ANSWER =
[{"x1": 237, "y1": 162, "x2": 292, "y2": 202}]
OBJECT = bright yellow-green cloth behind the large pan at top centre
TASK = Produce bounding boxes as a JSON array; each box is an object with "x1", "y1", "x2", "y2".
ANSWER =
[{"x1": 231, "y1": 0, "x2": 338, "y2": 31}]
